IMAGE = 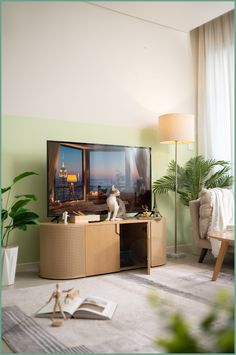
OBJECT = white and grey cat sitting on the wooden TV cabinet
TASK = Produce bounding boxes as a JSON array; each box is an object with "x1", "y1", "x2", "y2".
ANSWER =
[{"x1": 106, "y1": 185, "x2": 125, "y2": 221}]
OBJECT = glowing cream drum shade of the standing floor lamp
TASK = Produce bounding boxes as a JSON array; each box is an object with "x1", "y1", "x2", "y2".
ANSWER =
[{"x1": 159, "y1": 113, "x2": 194, "y2": 144}]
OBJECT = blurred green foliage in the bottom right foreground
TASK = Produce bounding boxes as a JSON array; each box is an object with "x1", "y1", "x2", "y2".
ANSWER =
[{"x1": 149, "y1": 289, "x2": 234, "y2": 354}]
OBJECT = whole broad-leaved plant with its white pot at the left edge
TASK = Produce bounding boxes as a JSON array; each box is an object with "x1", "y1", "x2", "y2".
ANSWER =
[{"x1": 1, "y1": 171, "x2": 38, "y2": 286}]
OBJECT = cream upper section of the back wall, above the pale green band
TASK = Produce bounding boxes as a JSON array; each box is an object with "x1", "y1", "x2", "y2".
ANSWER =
[{"x1": 2, "y1": 2, "x2": 195, "y2": 127}]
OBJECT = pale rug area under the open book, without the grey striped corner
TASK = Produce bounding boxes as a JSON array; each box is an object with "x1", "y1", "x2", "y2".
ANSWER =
[{"x1": 2, "y1": 263, "x2": 234, "y2": 354}]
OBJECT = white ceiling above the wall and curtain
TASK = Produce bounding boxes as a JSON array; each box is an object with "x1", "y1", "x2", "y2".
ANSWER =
[{"x1": 89, "y1": 1, "x2": 234, "y2": 32}]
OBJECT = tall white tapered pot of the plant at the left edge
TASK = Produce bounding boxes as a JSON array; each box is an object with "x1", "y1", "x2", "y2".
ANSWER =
[{"x1": 2, "y1": 246, "x2": 18, "y2": 286}]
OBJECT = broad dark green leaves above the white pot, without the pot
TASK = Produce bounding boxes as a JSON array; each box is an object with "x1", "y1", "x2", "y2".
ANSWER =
[{"x1": 1, "y1": 171, "x2": 39, "y2": 247}]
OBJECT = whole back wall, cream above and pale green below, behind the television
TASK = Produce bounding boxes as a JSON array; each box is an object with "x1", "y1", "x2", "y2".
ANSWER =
[{"x1": 2, "y1": 2, "x2": 196, "y2": 262}]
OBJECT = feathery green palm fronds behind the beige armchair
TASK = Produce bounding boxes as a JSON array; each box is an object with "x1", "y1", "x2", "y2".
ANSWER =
[{"x1": 153, "y1": 155, "x2": 233, "y2": 206}]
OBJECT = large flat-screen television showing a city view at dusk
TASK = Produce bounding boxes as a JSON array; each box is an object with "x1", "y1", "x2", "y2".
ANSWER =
[{"x1": 47, "y1": 140, "x2": 151, "y2": 217}]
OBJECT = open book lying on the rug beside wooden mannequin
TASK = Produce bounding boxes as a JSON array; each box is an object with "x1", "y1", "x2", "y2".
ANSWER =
[{"x1": 36, "y1": 297, "x2": 117, "y2": 319}]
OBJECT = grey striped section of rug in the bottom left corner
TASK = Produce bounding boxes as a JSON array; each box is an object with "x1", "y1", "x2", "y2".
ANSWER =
[{"x1": 2, "y1": 306, "x2": 92, "y2": 354}]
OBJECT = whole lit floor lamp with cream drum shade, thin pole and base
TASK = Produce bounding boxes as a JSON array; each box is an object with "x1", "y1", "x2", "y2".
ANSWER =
[{"x1": 159, "y1": 113, "x2": 194, "y2": 258}]
